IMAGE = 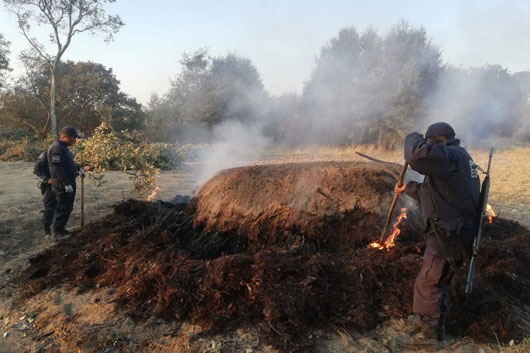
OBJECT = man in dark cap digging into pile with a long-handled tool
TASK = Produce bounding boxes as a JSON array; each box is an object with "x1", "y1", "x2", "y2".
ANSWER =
[{"x1": 395, "y1": 122, "x2": 480, "y2": 345}]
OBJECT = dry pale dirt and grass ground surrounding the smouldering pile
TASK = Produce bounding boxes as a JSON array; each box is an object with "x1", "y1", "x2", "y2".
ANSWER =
[{"x1": 0, "y1": 144, "x2": 530, "y2": 353}]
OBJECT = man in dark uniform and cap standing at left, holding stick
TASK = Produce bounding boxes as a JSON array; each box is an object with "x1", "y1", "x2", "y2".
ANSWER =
[{"x1": 44, "y1": 126, "x2": 87, "y2": 239}]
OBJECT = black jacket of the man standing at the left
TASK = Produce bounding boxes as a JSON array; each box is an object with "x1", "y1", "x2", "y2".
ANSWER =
[{"x1": 48, "y1": 141, "x2": 79, "y2": 186}]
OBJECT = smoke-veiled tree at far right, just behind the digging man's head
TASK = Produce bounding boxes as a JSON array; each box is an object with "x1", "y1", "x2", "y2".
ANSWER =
[{"x1": 430, "y1": 65, "x2": 528, "y2": 143}]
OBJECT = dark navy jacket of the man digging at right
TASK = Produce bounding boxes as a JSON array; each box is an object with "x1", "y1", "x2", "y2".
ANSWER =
[{"x1": 405, "y1": 132, "x2": 480, "y2": 252}]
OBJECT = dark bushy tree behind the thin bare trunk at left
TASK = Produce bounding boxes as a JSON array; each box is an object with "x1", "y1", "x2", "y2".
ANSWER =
[{"x1": 1, "y1": 56, "x2": 145, "y2": 136}]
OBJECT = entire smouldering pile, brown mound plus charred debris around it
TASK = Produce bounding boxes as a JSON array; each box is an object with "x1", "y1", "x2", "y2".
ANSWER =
[{"x1": 16, "y1": 163, "x2": 530, "y2": 351}]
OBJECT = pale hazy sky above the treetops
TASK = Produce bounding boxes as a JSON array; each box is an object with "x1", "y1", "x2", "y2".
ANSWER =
[{"x1": 0, "y1": 0, "x2": 530, "y2": 103}]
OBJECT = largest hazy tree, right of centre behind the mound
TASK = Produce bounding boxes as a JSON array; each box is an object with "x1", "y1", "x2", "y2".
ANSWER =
[{"x1": 302, "y1": 22, "x2": 443, "y2": 148}]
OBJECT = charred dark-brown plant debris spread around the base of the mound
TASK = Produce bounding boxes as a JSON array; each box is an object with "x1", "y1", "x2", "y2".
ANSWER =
[{"x1": 19, "y1": 163, "x2": 530, "y2": 351}]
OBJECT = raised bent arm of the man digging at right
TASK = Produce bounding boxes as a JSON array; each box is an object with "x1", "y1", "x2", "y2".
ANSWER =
[{"x1": 405, "y1": 132, "x2": 451, "y2": 179}]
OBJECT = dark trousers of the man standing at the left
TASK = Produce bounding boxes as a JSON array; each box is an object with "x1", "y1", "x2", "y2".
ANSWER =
[{"x1": 43, "y1": 185, "x2": 76, "y2": 229}]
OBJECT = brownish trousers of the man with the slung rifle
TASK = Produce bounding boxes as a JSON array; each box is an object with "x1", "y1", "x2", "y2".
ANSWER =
[{"x1": 412, "y1": 254, "x2": 453, "y2": 328}]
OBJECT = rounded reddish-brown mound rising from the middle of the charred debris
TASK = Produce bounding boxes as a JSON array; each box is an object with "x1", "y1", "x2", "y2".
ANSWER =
[{"x1": 192, "y1": 162, "x2": 400, "y2": 250}]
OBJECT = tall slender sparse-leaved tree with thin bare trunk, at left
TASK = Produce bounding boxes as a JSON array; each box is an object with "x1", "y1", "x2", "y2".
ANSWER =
[{"x1": 4, "y1": 0, "x2": 123, "y2": 134}]
